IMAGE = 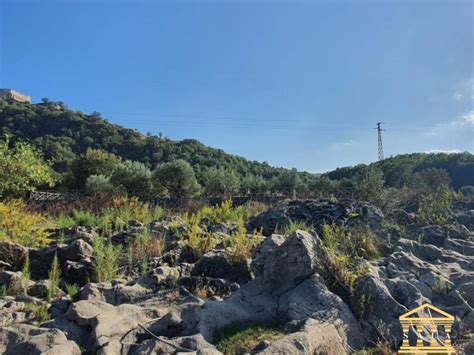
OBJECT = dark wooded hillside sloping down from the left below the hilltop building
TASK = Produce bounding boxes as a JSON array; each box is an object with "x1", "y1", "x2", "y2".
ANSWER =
[{"x1": 0, "y1": 100, "x2": 292, "y2": 184}]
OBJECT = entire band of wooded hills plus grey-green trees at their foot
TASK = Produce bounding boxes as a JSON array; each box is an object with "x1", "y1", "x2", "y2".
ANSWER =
[{"x1": 0, "y1": 99, "x2": 474, "y2": 200}]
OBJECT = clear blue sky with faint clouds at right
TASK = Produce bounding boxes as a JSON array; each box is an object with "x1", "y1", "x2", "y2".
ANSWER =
[{"x1": 0, "y1": 0, "x2": 474, "y2": 172}]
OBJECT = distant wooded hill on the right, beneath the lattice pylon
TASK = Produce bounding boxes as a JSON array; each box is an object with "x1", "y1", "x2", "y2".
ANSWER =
[{"x1": 324, "y1": 152, "x2": 474, "y2": 189}]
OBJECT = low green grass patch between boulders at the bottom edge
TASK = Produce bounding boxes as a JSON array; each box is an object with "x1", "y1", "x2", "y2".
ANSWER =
[{"x1": 214, "y1": 324, "x2": 285, "y2": 355}]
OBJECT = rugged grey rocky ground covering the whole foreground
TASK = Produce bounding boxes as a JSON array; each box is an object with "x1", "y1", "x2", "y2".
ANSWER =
[{"x1": 0, "y1": 200, "x2": 474, "y2": 354}]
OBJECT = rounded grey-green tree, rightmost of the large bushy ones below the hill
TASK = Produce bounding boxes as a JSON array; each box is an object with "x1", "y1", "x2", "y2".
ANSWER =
[{"x1": 153, "y1": 159, "x2": 201, "y2": 198}]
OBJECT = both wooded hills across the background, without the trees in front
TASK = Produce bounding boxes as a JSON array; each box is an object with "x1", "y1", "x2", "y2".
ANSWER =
[{"x1": 0, "y1": 99, "x2": 474, "y2": 197}]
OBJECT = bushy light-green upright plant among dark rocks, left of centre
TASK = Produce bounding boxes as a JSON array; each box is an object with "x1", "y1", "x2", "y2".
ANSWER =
[{"x1": 92, "y1": 237, "x2": 121, "y2": 282}]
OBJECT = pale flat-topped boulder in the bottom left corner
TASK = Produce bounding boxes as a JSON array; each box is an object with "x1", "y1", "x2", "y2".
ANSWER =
[{"x1": 0, "y1": 324, "x2": 81, "y2": 355}]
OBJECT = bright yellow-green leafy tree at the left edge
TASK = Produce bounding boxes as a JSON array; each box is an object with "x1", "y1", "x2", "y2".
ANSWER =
[{"x1": 0, "y1": 139, "x2": 55, "y2": 197}]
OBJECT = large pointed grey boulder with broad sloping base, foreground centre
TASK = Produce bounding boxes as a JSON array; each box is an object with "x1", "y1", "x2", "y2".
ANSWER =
[{"x1": 150, "y1": 231, "x2": 363, "y2": 353}]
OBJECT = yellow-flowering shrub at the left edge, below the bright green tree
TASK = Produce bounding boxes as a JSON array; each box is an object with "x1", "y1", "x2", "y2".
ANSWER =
[{"x1": 0, "y1": 200, "x2": 50, "y2": 247}]
